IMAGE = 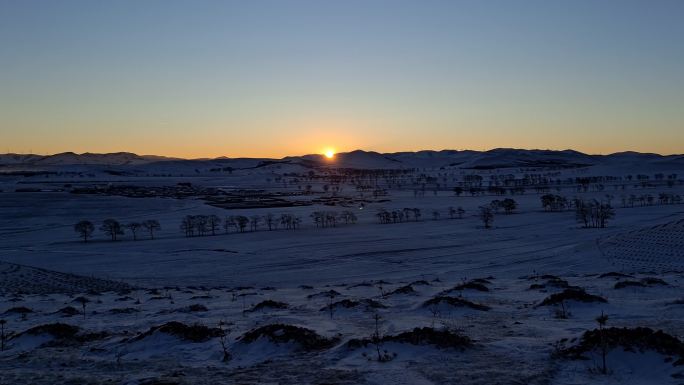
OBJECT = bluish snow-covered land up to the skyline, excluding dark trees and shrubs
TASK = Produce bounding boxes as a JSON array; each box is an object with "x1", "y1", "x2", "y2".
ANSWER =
[{"x1": 0, "y1": 150, "x2": 684, "y2": 384}]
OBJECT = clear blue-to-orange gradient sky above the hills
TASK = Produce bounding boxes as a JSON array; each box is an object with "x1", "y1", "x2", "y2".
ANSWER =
[{"x1": 0, "y1": 0, "x2": 684, "y2": 157}]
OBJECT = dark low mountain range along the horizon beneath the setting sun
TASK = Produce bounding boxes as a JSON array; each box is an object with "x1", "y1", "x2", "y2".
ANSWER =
[{"x1": 0, "y1": 148, "x2": 684, "y2": 172}]
